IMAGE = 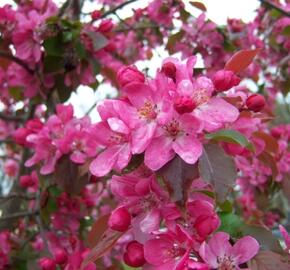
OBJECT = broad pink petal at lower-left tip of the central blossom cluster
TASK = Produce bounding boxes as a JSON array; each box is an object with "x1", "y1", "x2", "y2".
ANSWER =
[{"x1": 90, "y1": 145, "x2": 120, "y2": 177}]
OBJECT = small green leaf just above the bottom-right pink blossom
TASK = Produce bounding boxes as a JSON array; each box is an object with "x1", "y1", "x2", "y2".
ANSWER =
[{"x1": 218, "y1": 212, "x2": 243, "y2": 237}]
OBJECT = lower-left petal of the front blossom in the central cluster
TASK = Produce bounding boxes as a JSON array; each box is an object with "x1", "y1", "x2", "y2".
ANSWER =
[{"x1": 144, "y1": 136, "x2": 175, "y2": 171}]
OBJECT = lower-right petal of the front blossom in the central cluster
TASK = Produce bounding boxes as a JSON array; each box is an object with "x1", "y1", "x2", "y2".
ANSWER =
[{"x1": 172, "y1": 135, "x2": 202, "y2": 164}]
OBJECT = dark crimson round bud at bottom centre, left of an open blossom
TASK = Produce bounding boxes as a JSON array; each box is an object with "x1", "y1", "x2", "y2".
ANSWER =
[{"x1": 123, "y1": 241, "x2": 146, "y2": 267}]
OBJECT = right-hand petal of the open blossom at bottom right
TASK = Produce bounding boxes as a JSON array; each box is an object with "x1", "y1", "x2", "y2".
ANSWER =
[{"x1": 231, "y1": 236, "x2": 260, "y2": 265}]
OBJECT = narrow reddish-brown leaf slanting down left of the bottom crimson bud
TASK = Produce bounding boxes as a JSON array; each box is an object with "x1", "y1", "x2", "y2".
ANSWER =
[{"x1": 81, "y1": 229, "x2": 124, "y2": 270}]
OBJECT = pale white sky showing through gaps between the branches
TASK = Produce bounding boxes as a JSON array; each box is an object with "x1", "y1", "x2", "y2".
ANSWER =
[{"x1": 0, "y1": 0, "x2": 259, "y2": 121}]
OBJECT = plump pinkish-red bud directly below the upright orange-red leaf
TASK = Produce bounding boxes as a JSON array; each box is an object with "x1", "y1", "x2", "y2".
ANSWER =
[{"x1": 212, "y1": 70, "x2": 241, "y2": 92}]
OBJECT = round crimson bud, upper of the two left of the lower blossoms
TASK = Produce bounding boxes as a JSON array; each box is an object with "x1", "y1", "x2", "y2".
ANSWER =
[{"x1": 108, "y1": 207, "x2": 131, "y2": 232}]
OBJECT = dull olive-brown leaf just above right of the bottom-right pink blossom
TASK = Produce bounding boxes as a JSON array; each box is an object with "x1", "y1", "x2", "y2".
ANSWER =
[{"x1": 242, "y1": 225, "x2": 284, "y2": 254}]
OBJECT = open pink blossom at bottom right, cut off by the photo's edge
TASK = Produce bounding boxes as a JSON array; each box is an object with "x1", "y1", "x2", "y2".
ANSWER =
[{"x1": 199, "y1": 232, "x2": 259, "y2": 270}]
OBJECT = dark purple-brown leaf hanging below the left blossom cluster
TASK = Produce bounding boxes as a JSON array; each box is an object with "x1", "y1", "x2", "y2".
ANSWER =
[{"x1": 54, "y1": 155, "x2": 89, "y2": 194}]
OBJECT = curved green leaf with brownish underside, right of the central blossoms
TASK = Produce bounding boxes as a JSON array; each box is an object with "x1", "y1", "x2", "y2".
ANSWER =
[{"x1": 205, "y1": 129, "x2": 254, "y2": 151}]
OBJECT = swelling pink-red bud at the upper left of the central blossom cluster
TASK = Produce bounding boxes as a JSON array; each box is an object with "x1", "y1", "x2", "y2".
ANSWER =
[{"x1": 117, "y1": 66, "x2": 145, "y2": 87}]
